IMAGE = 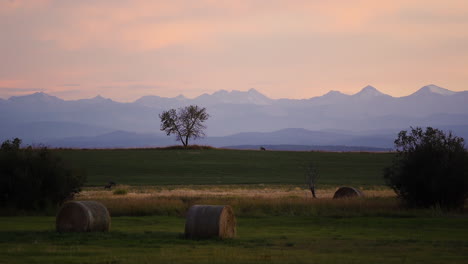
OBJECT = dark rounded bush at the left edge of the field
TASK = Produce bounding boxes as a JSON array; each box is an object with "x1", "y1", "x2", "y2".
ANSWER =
[{"x1": 0, "y1": 138, "x2": 86, "y2": 210}]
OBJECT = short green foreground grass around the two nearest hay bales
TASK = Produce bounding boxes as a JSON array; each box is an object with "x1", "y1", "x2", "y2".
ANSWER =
[{"x1": 0, "y1": 216, "x2": 468, "y2": 263}]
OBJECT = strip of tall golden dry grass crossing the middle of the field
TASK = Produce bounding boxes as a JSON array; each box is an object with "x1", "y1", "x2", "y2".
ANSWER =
[{"x1": 76, "y1": 185, "x2": 446, "y2": 217}]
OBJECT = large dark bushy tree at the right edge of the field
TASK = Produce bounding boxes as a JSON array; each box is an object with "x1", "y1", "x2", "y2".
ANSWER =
[{"x1": 384, "y1": 127, "x2": 468, "y2": 209}]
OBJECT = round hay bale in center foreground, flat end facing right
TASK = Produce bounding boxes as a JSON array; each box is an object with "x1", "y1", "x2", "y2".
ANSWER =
[{"x1": 185, "y1": 205, "x2": 236, "y2": 239}]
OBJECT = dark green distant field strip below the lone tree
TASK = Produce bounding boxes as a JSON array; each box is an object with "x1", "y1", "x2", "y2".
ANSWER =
[{"x1": 57, "y1": 149, "x2": 393, "y2": 186}]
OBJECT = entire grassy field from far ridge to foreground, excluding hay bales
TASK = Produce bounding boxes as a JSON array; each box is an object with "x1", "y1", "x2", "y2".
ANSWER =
[{"x1": 4, "y1": 149, "x2": 468, "y2": 264}]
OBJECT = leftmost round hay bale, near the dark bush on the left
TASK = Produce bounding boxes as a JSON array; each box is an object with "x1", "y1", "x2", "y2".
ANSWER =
[{"x1": 55, "y1": 201, "x2": 110, "y2": 232}]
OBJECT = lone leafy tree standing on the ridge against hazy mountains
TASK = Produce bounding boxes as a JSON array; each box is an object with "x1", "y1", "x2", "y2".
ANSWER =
[{"x1": 159, "y1": 105, "x2": 210, "y2": 148}]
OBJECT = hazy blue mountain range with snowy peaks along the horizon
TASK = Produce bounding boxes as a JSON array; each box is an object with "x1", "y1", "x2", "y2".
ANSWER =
[{"x1": 0, "y1": 85, "x2": 468, "y2": 148}]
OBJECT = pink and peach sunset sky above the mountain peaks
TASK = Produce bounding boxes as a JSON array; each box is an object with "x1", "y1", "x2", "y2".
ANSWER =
[{"x1": 0, "y1": 0, "x2": 468, "y2": 102}]
